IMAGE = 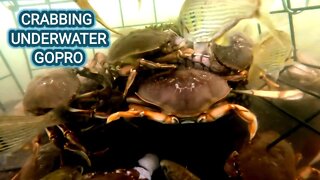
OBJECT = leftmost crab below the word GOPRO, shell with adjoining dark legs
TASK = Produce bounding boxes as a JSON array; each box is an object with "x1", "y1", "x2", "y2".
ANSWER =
[{"x1": 23, "y1": 53, "x2": 112, "y2": 115}]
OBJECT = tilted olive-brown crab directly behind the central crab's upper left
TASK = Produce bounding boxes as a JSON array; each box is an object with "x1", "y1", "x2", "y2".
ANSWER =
[{"x1": 107, "y1": 29, "x2": 193, "y2": 96}]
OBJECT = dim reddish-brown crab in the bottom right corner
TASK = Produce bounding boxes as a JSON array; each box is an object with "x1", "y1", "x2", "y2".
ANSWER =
[{"x1": 224, "y1": 131, "x2": 320, "y2": 180}]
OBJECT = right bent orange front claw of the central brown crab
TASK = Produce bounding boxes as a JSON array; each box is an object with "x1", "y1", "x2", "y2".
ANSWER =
[{"x1": 198, "y1": 104, "x2": 258, "y2": 140}]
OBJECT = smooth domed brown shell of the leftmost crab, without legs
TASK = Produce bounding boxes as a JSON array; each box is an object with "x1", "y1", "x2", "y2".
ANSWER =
[{"x1": 23, "y1": 69, "x2": 80, "y2": 115}]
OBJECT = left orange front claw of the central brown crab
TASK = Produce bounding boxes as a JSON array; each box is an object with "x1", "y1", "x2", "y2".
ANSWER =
[{"x1": 107, "y1": 109, "x2": 178, "y2": 124}]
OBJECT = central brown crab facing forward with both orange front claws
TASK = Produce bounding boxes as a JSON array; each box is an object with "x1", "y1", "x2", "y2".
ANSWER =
[{"x1": 107, "y1": 67, "x2": 258, "y2": 139}]
